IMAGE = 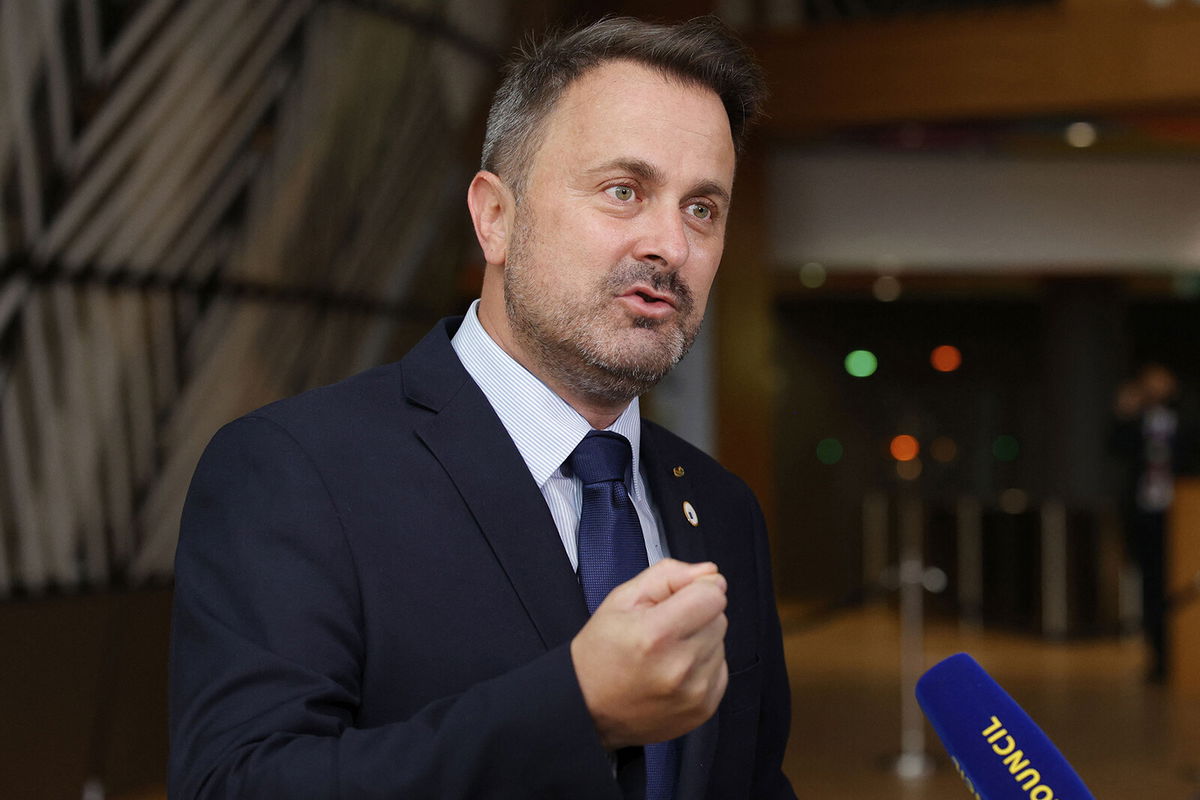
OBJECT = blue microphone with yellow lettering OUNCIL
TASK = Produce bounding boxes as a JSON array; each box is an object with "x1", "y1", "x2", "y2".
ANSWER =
[{"x1": 917, "y1": 652, "x2": 1094, "y2": 800}]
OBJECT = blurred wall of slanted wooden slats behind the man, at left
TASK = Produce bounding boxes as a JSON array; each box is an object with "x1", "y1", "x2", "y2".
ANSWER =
[{"x1": 0, "y1": 0, "x2": 499, "y2": 599}]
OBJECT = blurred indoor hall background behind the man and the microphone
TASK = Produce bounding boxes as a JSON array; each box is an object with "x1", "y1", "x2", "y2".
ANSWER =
[{"x1": 0, "y1": 0, "x2": 1200, "y2": 800}]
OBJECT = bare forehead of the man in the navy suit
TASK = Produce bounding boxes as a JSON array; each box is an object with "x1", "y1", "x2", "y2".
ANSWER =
[{"x1": 533, "y1": 60, "x2": 736, "y2": 190}]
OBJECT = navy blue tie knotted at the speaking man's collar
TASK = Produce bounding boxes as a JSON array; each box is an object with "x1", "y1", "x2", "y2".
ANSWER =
[{"x1": 566, "y1": 431, "x2": 679, "y2": 800}]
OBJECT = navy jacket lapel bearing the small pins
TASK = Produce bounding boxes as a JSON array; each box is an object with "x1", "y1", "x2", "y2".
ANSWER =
[{"x1": 642, "y1": 423, "x2": 716, "y2": 800}]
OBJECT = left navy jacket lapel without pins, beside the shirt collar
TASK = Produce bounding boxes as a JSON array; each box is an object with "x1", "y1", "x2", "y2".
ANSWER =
[{"x1": 403, "y1": 323, "x2": 588, "y2": 649}]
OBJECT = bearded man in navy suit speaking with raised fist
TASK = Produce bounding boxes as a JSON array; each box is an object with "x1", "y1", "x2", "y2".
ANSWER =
[{"x1": 170, "y1": 14, "x2": 794, "y2": 800}]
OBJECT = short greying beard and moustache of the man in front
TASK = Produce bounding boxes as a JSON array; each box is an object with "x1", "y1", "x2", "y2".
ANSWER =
[{"x1": 504, "y1": 255, "x2": 701, "y2": 404}]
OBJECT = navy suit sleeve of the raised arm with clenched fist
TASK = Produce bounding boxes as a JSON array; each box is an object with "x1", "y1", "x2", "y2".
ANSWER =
[{"x1": 169, "y1": 416, "x2": 620, "y2": 800}]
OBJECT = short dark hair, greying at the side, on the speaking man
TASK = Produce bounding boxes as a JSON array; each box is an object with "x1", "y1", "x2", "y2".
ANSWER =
[{"x1": 481, "y1": 16, "x2": 767, "y2": 197}]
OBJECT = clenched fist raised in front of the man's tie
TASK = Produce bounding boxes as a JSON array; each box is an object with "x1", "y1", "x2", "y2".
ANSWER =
[{"x1": 571, "y1": 559, "x2": 728, "y2": 750}]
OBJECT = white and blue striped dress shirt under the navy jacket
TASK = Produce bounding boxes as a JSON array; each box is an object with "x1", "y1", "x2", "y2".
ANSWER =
[{"x1": 450, "y1": 300, "x2": 668, "y2": 570}]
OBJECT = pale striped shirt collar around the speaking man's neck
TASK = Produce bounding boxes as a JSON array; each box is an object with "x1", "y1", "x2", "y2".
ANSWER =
[{"x1": 450, "y1": 300, "x2": 642, "y2": 497}]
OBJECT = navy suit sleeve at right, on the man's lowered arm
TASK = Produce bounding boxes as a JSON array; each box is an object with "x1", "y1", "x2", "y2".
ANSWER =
[{"x1": 746, "y1": 489, "x2": 796, "y2": 800}]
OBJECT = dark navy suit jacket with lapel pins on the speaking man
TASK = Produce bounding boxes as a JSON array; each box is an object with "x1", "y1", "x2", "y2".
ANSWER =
[{"x1": 169, "y1": 319, "x2": 794, "y2": 800}]
